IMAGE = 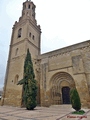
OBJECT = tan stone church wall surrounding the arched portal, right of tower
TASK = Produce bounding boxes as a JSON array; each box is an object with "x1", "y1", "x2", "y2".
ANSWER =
[{"x1": 38, "y1": 41, "x2": 90, "y2": 107}]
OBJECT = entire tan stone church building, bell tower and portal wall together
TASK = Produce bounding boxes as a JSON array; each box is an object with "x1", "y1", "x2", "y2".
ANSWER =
[{"x1": 2, "y1": 0, "x2": 90, "y2": 107}]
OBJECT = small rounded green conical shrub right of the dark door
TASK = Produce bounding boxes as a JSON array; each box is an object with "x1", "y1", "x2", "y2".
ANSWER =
[{"x1": 70, "y1": 88, "x2": 81, "y2": 111}]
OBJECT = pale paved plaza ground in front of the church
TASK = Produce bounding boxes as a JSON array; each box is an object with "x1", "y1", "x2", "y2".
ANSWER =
[{"x1": 0, "y1": 105, "x2": 90, "y2": 120}]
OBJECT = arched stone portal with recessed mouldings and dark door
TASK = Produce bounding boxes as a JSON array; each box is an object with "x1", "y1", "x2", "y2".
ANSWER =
[{"x1": 50, "y1": 72, "x2": 75, "y2": 104}]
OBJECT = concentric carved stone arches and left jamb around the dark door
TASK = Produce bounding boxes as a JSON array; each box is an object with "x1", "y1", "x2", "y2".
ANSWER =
[{"x1": 50, "y1": 72, "x2": 75, "y2": 104}]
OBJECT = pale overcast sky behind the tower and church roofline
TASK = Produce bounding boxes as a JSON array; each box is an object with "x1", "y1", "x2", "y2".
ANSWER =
[{"x1": 0, "y1": 0, "x2": 90, "y2": 88}]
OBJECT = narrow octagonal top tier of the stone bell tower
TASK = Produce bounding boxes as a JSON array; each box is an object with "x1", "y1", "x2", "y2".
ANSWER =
[{"x1": 14, "y1": 0, "x2": 41, "y2": 30}]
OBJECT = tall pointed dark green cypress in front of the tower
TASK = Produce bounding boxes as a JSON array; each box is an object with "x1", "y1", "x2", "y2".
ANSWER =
[{"x1": 18, "y1": 49, "x2": 37, "y2": 110}]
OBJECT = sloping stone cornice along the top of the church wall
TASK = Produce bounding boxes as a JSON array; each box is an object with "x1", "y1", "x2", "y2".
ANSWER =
[{"x1": 38, "y1": 40, "x2": 90, "y2": 59}]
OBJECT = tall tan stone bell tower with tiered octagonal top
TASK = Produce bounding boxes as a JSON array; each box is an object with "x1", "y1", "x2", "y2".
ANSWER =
[{"x1": 2, "y1": 0, "x2": 41, "y2": 106}]
